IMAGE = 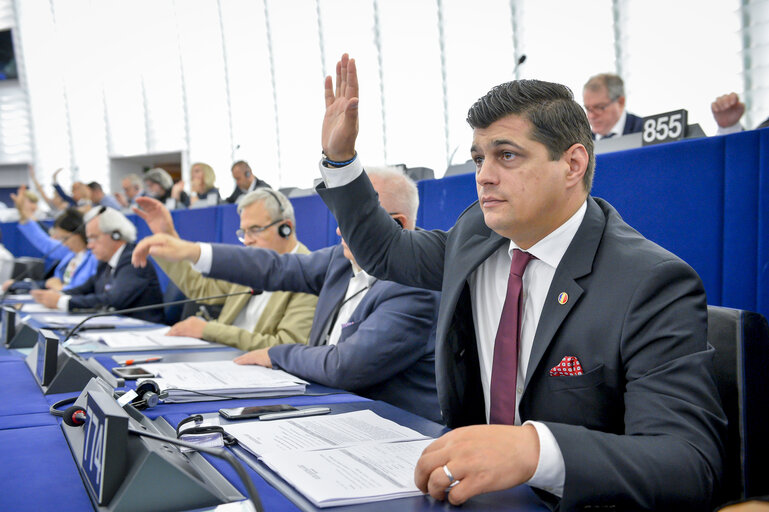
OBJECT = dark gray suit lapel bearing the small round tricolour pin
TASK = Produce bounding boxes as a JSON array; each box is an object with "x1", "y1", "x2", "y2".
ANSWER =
[{"x1": 524, "y1": 197, "x2": 606, "y2": 388}]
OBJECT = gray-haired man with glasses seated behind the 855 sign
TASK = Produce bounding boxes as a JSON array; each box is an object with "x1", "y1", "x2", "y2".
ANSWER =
[{"x1": 582, "y1": 73, "x2": 643, "y2": 140}]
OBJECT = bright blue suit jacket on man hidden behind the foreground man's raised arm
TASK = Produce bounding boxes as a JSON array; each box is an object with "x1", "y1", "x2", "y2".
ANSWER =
[{"x1": 204, "y1": 244, "x2": 440, "y2": 421}]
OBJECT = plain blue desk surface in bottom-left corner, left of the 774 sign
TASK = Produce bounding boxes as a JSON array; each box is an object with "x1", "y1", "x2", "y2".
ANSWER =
[{"x1": 0, "y1": 425, "x2": 93, "y2": 512}]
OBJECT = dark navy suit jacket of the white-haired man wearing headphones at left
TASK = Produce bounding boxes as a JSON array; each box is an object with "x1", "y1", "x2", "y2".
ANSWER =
[{"x1": 67, "y1": 244, "x2": 164, "y2": 323}]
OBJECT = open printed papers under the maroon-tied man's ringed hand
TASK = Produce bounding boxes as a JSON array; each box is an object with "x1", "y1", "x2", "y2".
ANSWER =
[{"x1": 224, "y1": 410, "x2": 433, "y2": 508}]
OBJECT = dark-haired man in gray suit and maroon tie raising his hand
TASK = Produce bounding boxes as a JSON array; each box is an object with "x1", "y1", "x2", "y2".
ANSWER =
[{"x1": 316, "y1": 54, "x2": 726, "y2": 511}]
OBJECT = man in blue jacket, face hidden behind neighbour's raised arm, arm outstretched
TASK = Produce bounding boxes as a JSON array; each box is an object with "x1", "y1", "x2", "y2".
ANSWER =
[{"x1": 134, "y1": 167, "x2": 441, "y2": 421}]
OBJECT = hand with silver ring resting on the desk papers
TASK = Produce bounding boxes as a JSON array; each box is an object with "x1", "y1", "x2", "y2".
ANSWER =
[{"x1": 414, "y1": 424, "x2": 539, "y2": 505}]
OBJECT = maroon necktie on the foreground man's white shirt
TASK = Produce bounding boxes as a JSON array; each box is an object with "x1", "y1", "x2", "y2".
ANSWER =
[{"x1": 489, "y1": 249, "x2": 534, "y2": 425}]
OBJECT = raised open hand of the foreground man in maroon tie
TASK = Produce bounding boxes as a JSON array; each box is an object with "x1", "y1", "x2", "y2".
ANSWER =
[{"x1": 321, "y1": 53, "x2": 358, "y2": 162}]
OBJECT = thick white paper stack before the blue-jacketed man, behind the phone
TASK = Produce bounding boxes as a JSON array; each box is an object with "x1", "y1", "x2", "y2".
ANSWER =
[{"x1": 138, "y1": 361, "x2": 308, "y2": 402}]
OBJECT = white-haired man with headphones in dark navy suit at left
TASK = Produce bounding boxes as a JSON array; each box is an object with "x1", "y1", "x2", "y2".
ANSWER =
[{"x1": 31, "y1": 207, "x2": 163, "y2": 323}]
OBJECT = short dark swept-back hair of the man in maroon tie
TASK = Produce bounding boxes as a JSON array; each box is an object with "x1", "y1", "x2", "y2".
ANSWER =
[{"x1": 467, "y1": 80, "x2": 595, "y2": 193}]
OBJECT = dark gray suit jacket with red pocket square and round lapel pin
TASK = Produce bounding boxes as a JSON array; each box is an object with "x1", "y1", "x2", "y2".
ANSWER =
[{"x1": 318, "y1": 173, "x2": 726, "y2": 510}]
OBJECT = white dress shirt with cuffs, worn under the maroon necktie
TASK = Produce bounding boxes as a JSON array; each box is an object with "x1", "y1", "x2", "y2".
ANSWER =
[{"x1": 319, "y1": 157, "x2": 584, "y2": 497}]
